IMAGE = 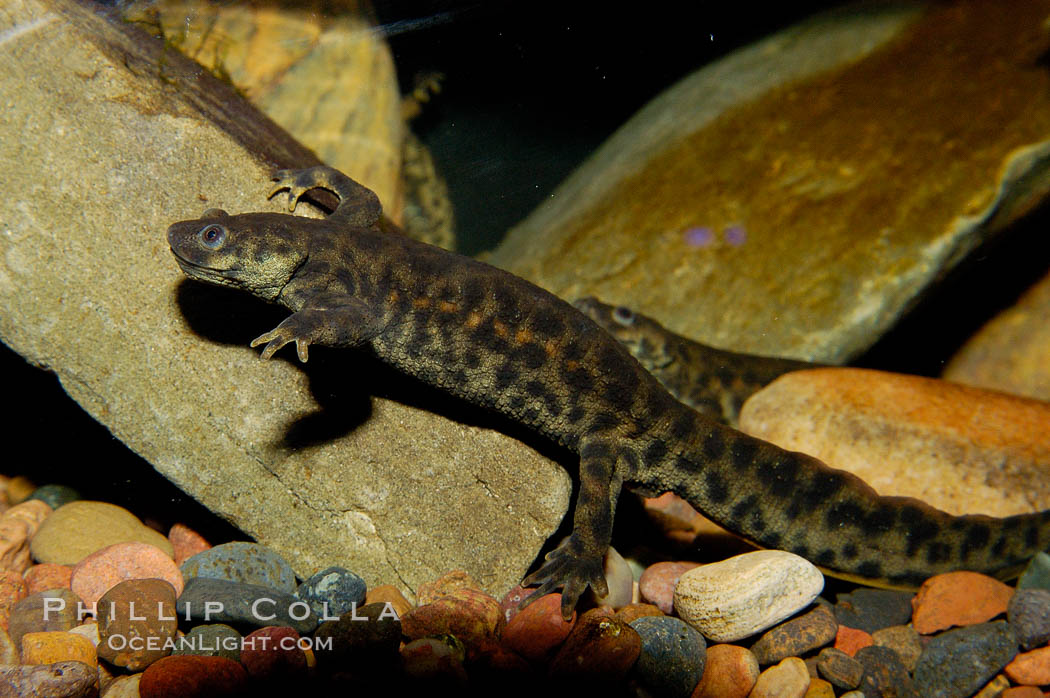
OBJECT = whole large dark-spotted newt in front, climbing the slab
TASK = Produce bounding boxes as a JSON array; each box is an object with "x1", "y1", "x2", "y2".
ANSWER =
[{"x1": 168, "y1": 168, "x2": 1050, "y2": 616}]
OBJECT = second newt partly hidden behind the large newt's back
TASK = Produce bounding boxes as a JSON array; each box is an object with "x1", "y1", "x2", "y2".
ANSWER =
[{"x1": 573, "y1": 298, "x2": 824, "y2": 426}]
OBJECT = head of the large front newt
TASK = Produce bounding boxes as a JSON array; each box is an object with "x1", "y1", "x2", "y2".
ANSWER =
[{"x1": 168, "y1": 209, "x2": 308, "y2": 300}]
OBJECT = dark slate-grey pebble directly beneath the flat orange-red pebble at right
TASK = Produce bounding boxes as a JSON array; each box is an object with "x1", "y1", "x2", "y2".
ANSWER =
[{"x1": 915, "y1": 620, "x2": 1017, "y2": 696}]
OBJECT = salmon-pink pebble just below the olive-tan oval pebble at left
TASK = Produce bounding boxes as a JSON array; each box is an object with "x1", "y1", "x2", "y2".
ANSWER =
[{"x1": 69, "y1": 543, "x2": 183, "y2": 608}]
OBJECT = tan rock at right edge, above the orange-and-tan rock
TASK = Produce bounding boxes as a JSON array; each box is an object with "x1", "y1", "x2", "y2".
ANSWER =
[{"x1": 943, "y1": 266, "x2": 1050, "y2": 400}]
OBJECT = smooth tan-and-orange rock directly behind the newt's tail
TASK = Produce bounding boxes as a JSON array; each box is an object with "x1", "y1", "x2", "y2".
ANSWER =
[{"x1": 740, "y1": 368, "x2": 1050, "y2": 516}]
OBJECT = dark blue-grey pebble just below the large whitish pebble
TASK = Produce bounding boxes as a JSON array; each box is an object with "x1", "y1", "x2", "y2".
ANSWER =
[{"x1": 630, "y1": 616, "x2": 707, "y2": 697}]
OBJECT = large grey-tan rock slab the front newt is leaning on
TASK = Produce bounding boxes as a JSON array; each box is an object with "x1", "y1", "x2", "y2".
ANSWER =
[{"x1": 0, "y1": 0, "x2": 569, "y2": 593}]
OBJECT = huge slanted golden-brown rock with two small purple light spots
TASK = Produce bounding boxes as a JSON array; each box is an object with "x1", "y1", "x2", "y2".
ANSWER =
[{"x1": 491, "y1": 0, "x2": 1050, "y2": 362}]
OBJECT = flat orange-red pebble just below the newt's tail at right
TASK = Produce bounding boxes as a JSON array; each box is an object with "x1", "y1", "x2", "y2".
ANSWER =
[{"x1": 911, "y1": 571, "x2": 1013, "y2": 635}]
